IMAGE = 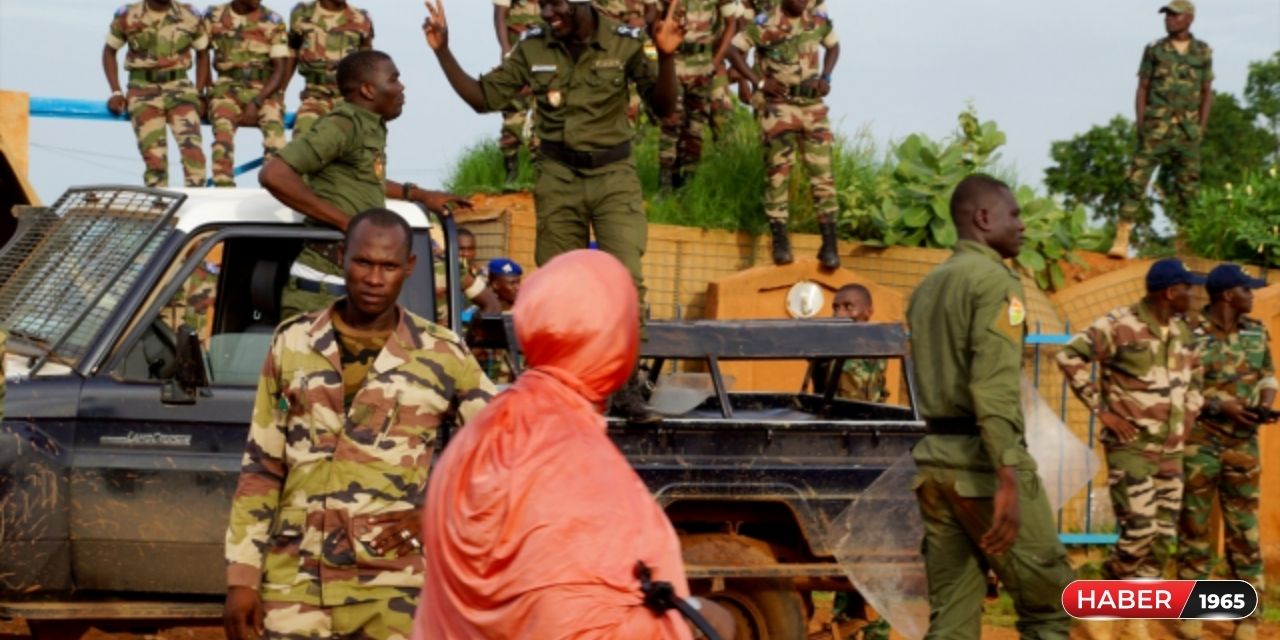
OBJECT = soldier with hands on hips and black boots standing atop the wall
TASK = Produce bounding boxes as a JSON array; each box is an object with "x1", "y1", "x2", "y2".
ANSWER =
[{"x1": 728, "y1": 0, "x2": 840, "y2": 269}]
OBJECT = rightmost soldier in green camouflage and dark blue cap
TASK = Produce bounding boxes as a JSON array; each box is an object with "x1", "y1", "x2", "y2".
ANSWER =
[{"x1": 1178, "y1": 265, "x2": 1276, "y2": 640}]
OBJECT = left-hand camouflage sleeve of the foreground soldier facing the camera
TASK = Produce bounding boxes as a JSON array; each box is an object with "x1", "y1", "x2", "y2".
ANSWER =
[{"x1": 227, "y1": 333, "x2": 288, "y2": 589}]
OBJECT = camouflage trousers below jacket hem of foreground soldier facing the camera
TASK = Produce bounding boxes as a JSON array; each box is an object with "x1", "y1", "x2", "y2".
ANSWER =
[{"x1": 262, "y1": 595, "x2": 417, "y2": 640}]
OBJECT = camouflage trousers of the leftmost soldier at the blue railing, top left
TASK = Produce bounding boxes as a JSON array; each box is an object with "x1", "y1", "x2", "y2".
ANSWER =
[{"x1": 128, "y1": 79, "x2": 205, "y2": 187}]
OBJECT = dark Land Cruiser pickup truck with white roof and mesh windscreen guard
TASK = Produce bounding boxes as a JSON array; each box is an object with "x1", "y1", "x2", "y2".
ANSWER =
[{"x1": 0, "y1": 187, "x2": 924, "y2": 639}]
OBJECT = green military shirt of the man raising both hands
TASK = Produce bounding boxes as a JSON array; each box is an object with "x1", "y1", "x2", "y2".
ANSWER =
[{"x1": 480, "y1": 12, "x2": 658, "y2": 151}]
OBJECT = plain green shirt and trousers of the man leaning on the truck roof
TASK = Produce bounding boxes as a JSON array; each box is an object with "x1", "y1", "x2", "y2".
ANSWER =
[{"x1": 279, "y1": 102, "x2": 387, "y2": 317}]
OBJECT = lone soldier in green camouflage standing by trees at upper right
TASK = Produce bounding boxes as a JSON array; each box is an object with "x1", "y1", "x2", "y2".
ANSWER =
[{"x1": 1107, "y1": 0, "x2": 1213, "y2": 257}]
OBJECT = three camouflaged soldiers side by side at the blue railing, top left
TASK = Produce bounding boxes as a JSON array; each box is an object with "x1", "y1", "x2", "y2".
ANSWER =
[{"x1": 102, "y1": 0, "x2": 374, "y2": 187}]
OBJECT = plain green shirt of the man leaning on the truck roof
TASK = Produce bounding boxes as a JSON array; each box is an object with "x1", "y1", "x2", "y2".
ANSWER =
[{"x1": 279, "y1": 102, "x2": 387, "y2": 216}]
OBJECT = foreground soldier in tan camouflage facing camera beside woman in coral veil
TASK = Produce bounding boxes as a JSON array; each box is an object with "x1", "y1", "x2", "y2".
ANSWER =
[{"x1": 224, "y1": 209, "x2": 495, "y2": 640}]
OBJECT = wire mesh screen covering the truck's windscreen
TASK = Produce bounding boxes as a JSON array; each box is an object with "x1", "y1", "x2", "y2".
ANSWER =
[{"x1": 0, "y1": 187, "x2": 186, "y2": 361}]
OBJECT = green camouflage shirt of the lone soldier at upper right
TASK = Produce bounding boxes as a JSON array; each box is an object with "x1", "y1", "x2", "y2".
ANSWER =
[{"x1": 1138, "y1": 37, "x2": 1213, "y2": 138}]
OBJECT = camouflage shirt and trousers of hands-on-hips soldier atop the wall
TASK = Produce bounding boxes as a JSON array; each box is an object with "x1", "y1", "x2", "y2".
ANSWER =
[{"x1": 733, "y1": 4, "x2": 838, "y2": 223}]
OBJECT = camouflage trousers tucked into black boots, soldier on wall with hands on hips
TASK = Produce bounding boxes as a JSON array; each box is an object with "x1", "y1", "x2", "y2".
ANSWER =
[{"x1": 759, "y1": 97, "x2": 837, "y2": 223}]
